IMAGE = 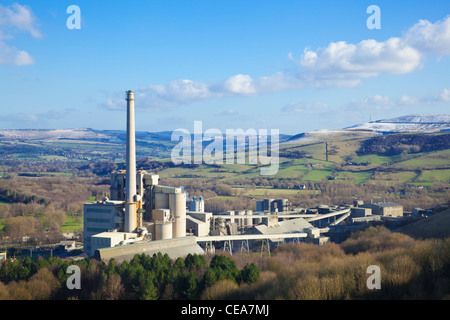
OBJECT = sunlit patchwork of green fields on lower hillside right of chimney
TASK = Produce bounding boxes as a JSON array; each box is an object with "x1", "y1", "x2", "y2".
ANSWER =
[{"x1": 153, "y1": 150, "x2": 450, "y2": 186}]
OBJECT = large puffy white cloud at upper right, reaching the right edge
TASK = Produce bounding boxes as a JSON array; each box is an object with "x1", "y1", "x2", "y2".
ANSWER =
[{"x1": 289, "y1": 16, "x2": 450, "y2": 87}]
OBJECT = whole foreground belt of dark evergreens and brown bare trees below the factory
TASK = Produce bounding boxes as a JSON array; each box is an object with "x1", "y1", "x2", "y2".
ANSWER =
[{"x1": 0, "y1": 226, "x2": 450, "y2": 300}]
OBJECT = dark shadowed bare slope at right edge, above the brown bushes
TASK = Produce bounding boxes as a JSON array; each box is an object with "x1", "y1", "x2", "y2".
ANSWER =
[{"x1": 395, "y1": 209, "x2": 450, "y2": 239}]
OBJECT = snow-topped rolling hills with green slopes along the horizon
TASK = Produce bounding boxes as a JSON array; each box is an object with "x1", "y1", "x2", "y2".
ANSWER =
[{"x1": 0, "y1": 115, "x2": 450, "y2": 186}]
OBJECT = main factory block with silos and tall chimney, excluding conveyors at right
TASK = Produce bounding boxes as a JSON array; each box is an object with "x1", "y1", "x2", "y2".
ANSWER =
[{"x1": 83, "y1": 91, "x2": 203, "y2": 259}]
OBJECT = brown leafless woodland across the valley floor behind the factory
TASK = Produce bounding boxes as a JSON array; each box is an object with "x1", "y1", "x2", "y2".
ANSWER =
[{"x1": 0, "y1": 169, "x2": 448, "y2": 245}]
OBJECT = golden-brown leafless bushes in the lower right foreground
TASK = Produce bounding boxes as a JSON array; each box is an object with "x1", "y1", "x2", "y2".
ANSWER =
[{"x1": 229, "y1": 226, "x2": 450, "y2": 300}]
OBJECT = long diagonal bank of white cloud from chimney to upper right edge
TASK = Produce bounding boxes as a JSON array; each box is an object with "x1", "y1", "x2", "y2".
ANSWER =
[{"x1": 102, "y1": 16, "x2": 450, "y2": 111}]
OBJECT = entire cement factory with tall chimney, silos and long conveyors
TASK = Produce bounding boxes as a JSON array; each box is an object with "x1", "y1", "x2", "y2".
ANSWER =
[{"x1": 83, "y1": 91, "x2": 403, "y2": 261}]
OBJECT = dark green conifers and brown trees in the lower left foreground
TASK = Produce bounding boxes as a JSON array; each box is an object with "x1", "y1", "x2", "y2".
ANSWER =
[{"x1": 0, "y1": 253, "x2": 260, "y2": 300}]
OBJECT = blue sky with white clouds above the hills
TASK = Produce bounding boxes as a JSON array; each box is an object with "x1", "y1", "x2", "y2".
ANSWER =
[{"x1": 0, "y1": 0, "x2": 450, "y2": 134}]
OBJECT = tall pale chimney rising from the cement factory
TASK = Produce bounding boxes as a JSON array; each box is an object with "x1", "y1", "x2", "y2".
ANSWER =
[{"x1": 124, "y1": 90, "x2": 137, "y2": 232}]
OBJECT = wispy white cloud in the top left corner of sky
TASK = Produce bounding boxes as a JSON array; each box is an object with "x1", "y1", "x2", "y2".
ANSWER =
[{"x1": 0, "y1": 3, "x2": 42, "y2": 66}]
